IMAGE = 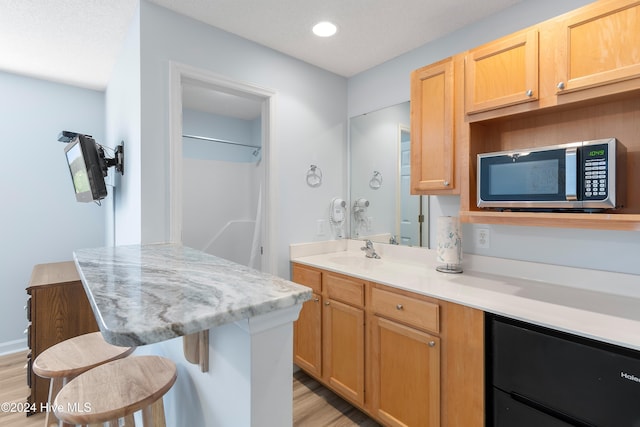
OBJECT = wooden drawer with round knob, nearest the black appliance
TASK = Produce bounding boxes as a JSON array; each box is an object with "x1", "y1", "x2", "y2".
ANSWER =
[{"x1": 371, "y1": 288, "x2": 440, "y2": 333}]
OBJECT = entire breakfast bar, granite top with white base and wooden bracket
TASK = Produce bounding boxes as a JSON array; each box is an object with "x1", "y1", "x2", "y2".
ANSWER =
[{"x1": 74, "y1": 243, "x2": 311, "y2": 427}]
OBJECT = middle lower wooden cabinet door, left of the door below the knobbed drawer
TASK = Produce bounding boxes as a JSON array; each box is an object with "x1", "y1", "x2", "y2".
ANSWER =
[{"x1": 322, "y1": 300, "x2": 364, "y2": 405}]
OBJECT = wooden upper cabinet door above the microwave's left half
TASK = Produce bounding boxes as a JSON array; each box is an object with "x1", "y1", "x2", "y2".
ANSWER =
[{"x1": 464, "y1": 30, "x2": 538, "y2": 114}]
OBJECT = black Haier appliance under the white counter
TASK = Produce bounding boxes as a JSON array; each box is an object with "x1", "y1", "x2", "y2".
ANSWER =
[{"x1": 486, "y1": 314, "x2": 640, "y2": 427}]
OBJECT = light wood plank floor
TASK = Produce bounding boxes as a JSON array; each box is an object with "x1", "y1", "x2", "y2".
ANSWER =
[{"x1": 0, "y1": 352, "x2": 379, "y2": 427}]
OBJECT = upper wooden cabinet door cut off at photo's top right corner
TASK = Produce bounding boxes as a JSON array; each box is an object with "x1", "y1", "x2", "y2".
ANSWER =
[{"x1": 558, "y1": 0, "x2": 640, "y2": 94}]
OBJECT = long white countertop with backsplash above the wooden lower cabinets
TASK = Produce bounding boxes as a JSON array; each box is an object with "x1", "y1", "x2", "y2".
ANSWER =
[{"x1": 290, "y1": 240, "x2": 640, "y2": 350}]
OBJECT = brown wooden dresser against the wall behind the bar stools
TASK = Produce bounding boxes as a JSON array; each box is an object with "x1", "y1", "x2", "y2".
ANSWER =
[{"x1": 26, "y1": 261, "x2": 98, "y2": 415}]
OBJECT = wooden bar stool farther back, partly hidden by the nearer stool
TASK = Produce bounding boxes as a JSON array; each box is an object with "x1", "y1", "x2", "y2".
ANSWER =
[{"x1": 33, "y1": 332, "x2": 135, "y2": 427}]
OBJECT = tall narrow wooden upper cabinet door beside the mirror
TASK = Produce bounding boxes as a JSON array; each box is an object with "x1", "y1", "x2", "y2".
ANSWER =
[{"x1": 411, "y1": 58, "x2": 456, "y2": 194}]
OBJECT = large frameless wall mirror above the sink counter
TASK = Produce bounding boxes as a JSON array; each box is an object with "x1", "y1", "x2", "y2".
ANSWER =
[{"x1": 349, "y1": 101, "x2": 429, "y2": 247}]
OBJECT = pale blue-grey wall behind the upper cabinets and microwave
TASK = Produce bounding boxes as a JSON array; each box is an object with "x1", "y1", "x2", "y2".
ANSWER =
[{"x1": 348, "y1": 0, "x2": 640, "y2": 274}]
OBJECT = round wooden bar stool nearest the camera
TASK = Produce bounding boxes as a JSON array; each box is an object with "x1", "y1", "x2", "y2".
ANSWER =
[{"x1": 53, "y1": 356, "x2": 177, "y2": 427}]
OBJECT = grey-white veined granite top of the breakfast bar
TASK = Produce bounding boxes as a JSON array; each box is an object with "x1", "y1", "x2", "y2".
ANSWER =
[{"x1": 74, "y1": 243, "x2": 311, "y2": 346}]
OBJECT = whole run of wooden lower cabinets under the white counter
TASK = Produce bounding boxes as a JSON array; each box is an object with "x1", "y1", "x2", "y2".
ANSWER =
[{"x1": 292, "y1": 263, "x2": 484, "y2": 427}]
